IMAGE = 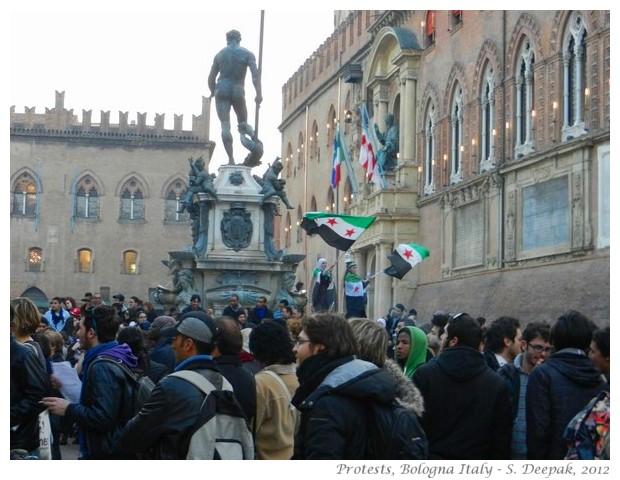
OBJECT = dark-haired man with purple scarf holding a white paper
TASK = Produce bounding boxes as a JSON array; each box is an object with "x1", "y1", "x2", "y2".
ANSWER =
[{"x1": 43, "y1": 305, "x2": 138, "y2": 460}]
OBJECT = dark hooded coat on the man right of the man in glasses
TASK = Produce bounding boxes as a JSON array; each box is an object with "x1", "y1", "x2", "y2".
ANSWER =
[{"x1": 525, "y1": 349, "x2": 609, "y2": 460}]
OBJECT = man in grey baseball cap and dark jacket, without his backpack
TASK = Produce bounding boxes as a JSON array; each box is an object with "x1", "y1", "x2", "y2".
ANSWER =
[{"x1": 121, "y1": 315, "x2": 251, "y2": 460}]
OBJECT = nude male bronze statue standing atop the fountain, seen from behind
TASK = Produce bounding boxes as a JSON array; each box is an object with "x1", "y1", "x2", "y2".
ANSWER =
[{"x1": 208, "y1": 30, "x2": 263, "y2": 165}]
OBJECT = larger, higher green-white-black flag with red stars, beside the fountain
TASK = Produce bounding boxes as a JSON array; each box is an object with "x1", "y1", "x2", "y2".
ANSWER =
[{"x1": 301, "y1": 212, "x2": 376, "y2": 251}]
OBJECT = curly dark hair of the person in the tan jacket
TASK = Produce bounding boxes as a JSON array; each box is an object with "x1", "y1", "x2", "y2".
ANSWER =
[{"x1": 250, "y1": 322, "x2": 295, "y2": 365}]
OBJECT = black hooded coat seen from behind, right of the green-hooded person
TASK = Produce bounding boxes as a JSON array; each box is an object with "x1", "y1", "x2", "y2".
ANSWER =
[{"x1": 413, "y1": 346, "x2": 512, "y2": 460}]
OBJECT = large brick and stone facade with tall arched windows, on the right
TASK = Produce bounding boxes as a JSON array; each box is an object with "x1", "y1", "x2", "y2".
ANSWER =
[{"x1": 279, "y1": 10, "x2": 611, "y2": 324}]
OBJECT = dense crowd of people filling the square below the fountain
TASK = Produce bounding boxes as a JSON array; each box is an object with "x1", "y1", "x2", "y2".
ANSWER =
[{"x1": 11, "y1": 288, "x2": 610, "y2": 460}]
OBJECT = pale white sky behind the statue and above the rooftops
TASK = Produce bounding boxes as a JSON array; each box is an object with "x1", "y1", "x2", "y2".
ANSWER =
[{"x1": 8, "y1": 0, "x2": 334, "y2": 173}]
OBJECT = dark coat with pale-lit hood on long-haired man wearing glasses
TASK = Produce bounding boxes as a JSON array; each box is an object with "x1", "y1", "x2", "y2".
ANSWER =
[{"x1": 292, "y1": 354, "x2": 397, "y2": 460}]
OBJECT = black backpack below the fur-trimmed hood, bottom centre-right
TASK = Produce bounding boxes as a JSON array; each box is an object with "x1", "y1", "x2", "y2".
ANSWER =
[{"x1": 366, "y1": 402, "x2": 429, "y2": 460}]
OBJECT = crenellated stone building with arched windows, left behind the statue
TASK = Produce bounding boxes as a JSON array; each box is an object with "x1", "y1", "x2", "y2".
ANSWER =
[{"x1": 10, "y1": 92, "x2": 215, "y2": 307}]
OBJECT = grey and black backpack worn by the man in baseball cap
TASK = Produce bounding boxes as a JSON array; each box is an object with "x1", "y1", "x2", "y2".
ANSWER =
[{"x1": 168, "y1": 370, "x2": 254, "y2": 460}]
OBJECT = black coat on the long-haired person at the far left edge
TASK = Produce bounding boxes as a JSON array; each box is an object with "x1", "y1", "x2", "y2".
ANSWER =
[{"x1": 11, "y1": 337, "x2": 50, "y2": 452}]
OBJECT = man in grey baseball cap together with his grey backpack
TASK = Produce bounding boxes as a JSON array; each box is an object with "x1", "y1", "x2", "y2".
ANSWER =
[{"x1": 120, "y1": 316, "x2": 254, "y2": 460}]
